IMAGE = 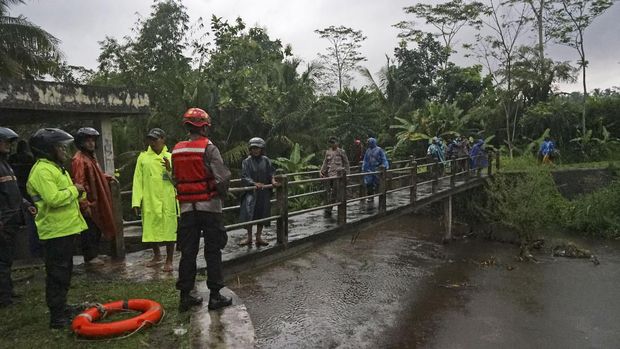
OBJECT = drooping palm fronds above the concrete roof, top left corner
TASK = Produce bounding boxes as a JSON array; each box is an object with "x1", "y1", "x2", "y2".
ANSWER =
[{"x1": 0, "y1": 0, "x2": 62, "y2": 79}]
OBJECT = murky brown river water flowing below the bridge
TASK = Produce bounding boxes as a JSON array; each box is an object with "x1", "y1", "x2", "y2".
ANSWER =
[{"x1": 230, "y1": 216, "x2": 620, "y2": 348}]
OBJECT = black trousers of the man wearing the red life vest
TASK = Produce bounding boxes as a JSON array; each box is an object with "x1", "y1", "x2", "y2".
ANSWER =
[{"x1": 176, "y1": 211, "x2": 228, "y2": 292}]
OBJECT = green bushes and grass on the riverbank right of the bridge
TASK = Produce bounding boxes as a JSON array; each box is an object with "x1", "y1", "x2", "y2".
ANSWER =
[{"x1": 480, "y1": 166, "x2": 620, "y2": 247}]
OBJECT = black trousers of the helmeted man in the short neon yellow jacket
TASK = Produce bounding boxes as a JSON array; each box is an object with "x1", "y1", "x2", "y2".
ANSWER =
[{"x1": 41, "y1": 235, "x2": 75, "y2": 319}]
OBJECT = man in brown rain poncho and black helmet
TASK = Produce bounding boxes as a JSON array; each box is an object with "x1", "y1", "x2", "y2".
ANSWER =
[{"x1": 71, "y1": 127, "x2": 116, "y2": 264}]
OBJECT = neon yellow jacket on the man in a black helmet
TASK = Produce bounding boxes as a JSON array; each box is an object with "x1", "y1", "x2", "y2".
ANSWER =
[{"x1": 26, "y1": 159, "x2": 88, "y2": 240}]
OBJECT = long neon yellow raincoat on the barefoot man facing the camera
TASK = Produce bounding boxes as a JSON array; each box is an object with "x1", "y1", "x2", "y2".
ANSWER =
[{"x1": 131, "y1": 146, "x2": 179, "y2": 242}]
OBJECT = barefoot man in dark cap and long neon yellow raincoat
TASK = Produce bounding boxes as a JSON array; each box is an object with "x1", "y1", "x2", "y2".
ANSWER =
[{"x1": 131, "y1": 128, "x2": 179, "y2": 272}]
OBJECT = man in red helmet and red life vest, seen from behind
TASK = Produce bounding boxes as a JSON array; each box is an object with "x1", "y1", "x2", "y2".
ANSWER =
[{"x1": 172, "y1": 108, "x2": 232, "y2": 311}]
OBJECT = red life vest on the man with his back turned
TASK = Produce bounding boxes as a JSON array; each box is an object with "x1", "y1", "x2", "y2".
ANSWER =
[{"x1": 172, "y1": 137, "x2": 217, "y2": 203}]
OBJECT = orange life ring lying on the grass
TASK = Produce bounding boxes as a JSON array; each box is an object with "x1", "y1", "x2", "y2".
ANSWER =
[{"x1": 71, "y1": 299, "x2": 164, "y2": 337}]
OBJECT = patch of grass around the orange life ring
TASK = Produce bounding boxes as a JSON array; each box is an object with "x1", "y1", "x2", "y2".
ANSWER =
[{"x1": 0, "y1": 268, "x2": 190, "y2": 349}]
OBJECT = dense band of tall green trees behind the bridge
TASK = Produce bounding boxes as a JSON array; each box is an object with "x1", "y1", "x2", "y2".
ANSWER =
[{"x1": 0, "y1": 0, "x2": 620, "y2": 174}]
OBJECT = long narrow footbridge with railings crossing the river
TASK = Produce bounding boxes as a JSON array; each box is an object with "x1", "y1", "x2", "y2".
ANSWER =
[{"x1": 116, "y1": 154, "x2": 499, "y2": 270}]
